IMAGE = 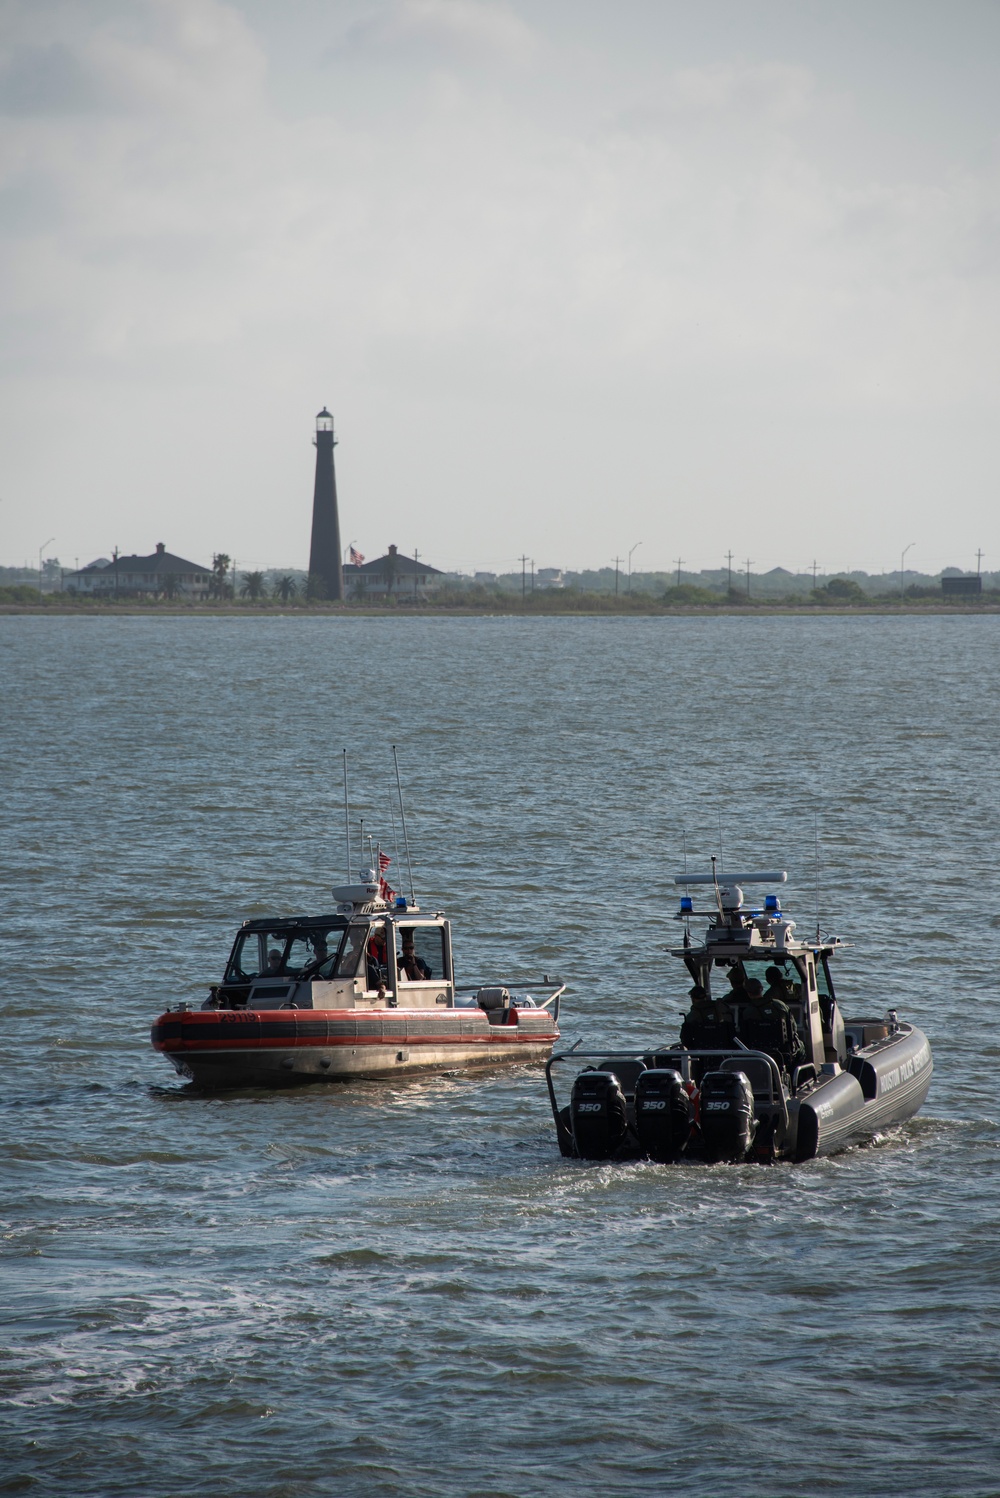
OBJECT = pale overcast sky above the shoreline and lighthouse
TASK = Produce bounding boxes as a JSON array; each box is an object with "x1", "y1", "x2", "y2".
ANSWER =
[{"x1": 0, "y1": 0, "x2": 1000, "y2": 572}]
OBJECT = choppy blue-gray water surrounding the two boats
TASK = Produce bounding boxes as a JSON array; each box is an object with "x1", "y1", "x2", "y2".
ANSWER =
[{"x1": 0, "y1": 617, "x2": 1000, "y2": 1498}]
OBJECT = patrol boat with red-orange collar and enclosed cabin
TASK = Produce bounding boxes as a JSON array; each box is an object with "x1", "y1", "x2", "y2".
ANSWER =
[{"x1": 151, "y1": 860, "x2": 564, "y2": 1089}]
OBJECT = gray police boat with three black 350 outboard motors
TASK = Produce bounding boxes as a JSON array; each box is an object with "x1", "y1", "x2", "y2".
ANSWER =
[{"x1": 545, "y1": 858, "x2": 933, "y2": 1164}]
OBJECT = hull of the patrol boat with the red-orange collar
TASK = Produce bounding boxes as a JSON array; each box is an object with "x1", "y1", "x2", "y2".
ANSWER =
[{"x1": 151, "y1": 1008, "x2": 558, "y2": 1089}]
